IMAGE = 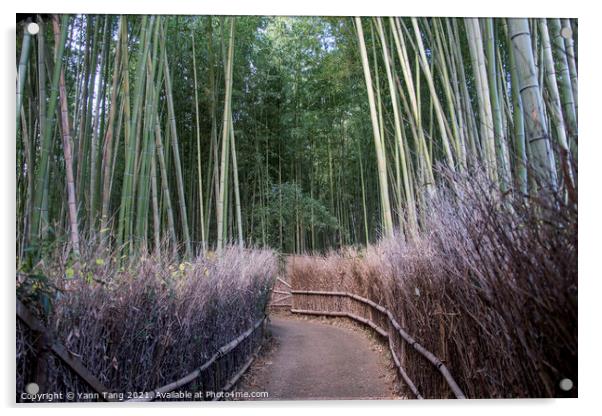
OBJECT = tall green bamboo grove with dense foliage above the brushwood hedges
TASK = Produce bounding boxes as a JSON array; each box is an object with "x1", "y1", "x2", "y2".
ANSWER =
[{"x1": 17, "y1": 15, "x2": 577, "y2": 262}]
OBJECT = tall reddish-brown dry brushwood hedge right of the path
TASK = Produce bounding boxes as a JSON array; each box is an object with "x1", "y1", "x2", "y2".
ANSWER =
[{"x1": 287, "y1": 169, "x2": 577, "y2": 398}]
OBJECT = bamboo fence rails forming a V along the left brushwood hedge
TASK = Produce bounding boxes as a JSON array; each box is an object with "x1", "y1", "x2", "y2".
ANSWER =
[{"x1": 16, "y1": 299, "x2": 267, "y2": 402}]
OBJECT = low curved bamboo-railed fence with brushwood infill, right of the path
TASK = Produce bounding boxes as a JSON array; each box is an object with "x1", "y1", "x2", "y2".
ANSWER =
[{"x1": 291, "y1": 290, "x2": 466, "y2": 399}]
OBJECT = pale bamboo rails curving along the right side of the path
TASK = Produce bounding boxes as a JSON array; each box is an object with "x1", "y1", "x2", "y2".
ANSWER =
[{"x1": 291, "y1": 290, "x2": 466, "y2": 399}]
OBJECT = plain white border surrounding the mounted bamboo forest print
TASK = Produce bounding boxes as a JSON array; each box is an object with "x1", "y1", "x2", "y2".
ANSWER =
[{"x1": 0, "y1": 0, "x2": 602, "y2": 416}]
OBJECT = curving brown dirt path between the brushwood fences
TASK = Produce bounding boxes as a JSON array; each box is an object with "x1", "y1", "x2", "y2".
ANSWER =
[{"x1": 236, "y1": 317, "x2": 396, "y2": 400}]
